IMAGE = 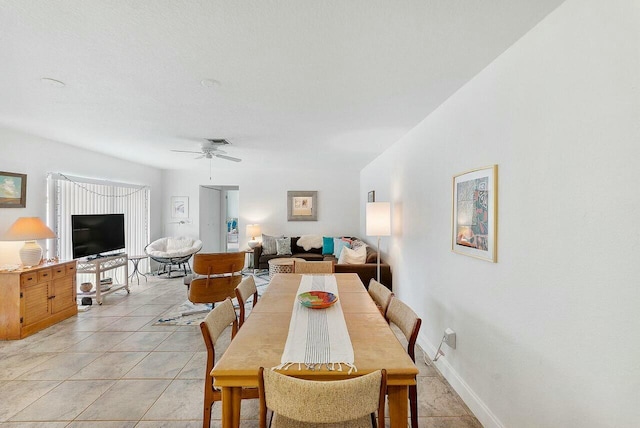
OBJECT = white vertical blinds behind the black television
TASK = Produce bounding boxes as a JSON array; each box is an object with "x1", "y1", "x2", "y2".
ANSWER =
[{"x1": 47, "y1": 173, "x2": 150, "y2": 260}]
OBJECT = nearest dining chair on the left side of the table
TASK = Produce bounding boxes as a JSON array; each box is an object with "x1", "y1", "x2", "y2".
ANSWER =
[{"x1": 200, "y1": 298, "x2": 259, "y2": 428}]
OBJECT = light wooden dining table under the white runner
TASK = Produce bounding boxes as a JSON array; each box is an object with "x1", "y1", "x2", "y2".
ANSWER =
[{"x1": 211, "y1": 273, "x2": 418, "y2": 428}]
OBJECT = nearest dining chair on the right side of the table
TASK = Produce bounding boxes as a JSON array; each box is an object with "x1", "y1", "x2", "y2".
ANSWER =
[{"x1": 387, "y1": 296, "x2": 422, "y2": 428}]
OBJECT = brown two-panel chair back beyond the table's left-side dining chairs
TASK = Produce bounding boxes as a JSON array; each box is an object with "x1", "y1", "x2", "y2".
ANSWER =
[{"x1": 189, "y1": 253, "x2": 245, "y2": 303}]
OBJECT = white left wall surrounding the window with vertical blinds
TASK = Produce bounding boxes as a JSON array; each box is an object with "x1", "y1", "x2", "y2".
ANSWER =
[{"x1": 0, "y1": 128, "x2": 161, "y2": 264}]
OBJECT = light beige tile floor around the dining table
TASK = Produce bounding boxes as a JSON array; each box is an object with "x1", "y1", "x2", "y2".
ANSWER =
[{"x1": 0, "y1": 277, "x2": 481, "y2": 428}]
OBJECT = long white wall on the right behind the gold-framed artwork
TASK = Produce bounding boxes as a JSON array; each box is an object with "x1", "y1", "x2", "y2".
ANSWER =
[{"x1": 360, "y1": 0, "x2": 640, "y2": 428}]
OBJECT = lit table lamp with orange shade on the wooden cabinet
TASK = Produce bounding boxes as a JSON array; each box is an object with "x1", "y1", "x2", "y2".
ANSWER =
[{"x1": 1, "y1": 217, "x2": 56, "y2": 267}]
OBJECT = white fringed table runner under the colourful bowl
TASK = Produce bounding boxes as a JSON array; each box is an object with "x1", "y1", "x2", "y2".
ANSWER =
[{"x1": 274, "y1": 275, "x2": 357, "y2": 374}]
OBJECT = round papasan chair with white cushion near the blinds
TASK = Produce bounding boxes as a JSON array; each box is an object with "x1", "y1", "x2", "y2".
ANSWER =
[{"x1": 144, "y1": 237, "x2": 202, "y2": 278}]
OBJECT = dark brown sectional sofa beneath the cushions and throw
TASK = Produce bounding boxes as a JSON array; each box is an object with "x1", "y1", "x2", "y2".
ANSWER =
[{"x1": 253, "y1": 236, "x2": 392, "y2": 290}]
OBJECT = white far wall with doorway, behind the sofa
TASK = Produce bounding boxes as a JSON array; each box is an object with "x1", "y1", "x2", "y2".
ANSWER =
[{"x1": 162, "y1": 166, "x2": 360, "y2": 244}]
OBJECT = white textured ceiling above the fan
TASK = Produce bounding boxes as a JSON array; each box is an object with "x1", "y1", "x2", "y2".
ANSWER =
[{"x1": 0, "y1": 0, "x2": 562, "y2": 169}]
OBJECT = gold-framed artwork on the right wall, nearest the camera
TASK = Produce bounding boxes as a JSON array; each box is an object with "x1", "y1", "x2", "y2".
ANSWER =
[{"x1": 451, "y1": 165, "x2": 498, "y2": 263}]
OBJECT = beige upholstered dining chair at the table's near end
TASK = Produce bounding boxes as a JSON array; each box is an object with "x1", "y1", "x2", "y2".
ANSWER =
[{"x1": 258, "y1": 367, "x2": 387, "y2": 428}]
